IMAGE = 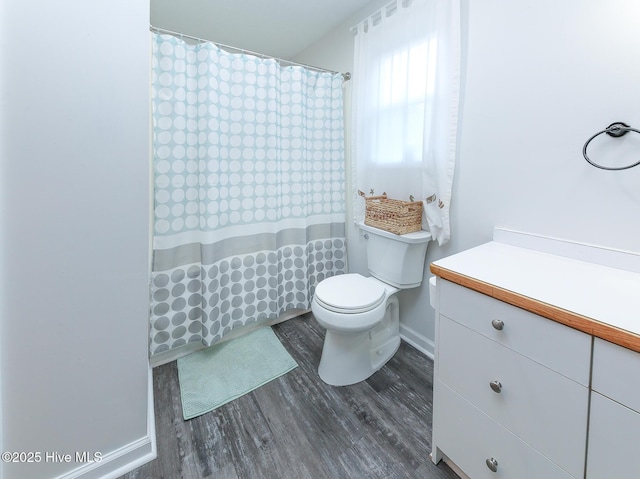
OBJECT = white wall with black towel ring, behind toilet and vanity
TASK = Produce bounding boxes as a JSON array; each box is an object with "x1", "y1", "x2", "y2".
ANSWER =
[{"x1": 297, "y1": 0, "x2": 640, "y2": 356}]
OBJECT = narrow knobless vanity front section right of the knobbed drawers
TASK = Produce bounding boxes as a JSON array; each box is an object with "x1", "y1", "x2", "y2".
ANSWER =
[{"x1": 586, "y1": 338, "x2": 640, "y2": 479}]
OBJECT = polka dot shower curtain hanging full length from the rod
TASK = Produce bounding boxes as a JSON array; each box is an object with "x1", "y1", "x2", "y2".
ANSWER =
[{"x1": 150, "y1": 34, "x2": 346, "y2": 362}]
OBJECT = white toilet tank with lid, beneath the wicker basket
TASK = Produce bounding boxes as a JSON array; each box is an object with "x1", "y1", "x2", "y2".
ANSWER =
[{"x1": 358, "y1": 223, "x2": 431, "y2": 289}]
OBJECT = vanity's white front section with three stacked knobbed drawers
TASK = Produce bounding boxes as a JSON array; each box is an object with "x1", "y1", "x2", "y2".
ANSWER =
[{"x1": 433, "y1": 281, "x2": 591, "y2": 479}]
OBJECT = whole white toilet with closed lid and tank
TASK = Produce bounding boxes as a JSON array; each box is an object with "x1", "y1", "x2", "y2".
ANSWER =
[{"x1": 311, "y1": 223, "x2": 431, "y2": 386}]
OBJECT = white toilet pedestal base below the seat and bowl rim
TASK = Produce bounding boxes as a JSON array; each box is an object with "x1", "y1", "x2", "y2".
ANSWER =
[{"x1": 318, "y1": 296, "x2": 400, "y2": 386}]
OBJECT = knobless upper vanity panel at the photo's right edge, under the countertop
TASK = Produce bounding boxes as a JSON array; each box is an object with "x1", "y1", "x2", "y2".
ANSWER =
[{"x1": 591, "y1": 338, "x2": 640, "y2": 412}]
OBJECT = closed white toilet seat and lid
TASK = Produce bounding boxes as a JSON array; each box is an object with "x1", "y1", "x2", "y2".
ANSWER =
[{"x1": 314, "y1": 273, "x2": 386, "y2": 314}]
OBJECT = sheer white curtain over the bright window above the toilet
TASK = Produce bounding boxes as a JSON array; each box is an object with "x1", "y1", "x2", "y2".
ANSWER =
[{"x1": 352, "y1": 0, "x2": 460, "y2": 244}]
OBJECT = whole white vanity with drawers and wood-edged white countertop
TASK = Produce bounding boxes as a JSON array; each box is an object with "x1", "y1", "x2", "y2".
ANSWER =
[{"x1": 430, "y1": 229, "x2": 640, "y2": 479}]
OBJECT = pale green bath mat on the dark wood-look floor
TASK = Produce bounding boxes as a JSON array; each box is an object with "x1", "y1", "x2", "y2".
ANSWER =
[{"x1": 178, "y1": 326, "x2": 298, "y2": 419}]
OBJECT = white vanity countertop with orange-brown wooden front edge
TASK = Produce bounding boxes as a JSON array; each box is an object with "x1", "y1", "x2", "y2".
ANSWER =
[{"x1": 430, "y1": 236, "x2": 640, "y2": 352}]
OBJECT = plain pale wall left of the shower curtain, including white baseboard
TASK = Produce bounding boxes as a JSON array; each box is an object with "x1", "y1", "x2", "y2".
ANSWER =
[{"x1": 0, "y1": 0, "x2": 154, "y2": 479}]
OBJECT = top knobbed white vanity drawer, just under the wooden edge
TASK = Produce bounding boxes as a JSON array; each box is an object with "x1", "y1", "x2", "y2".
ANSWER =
[{"x1": 438, "y1": 278, "x2": 591, "y2": 386}]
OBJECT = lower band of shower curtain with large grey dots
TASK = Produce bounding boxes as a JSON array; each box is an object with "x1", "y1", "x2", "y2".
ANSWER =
[{"x1": 150, "y1": 237, "x2": 347, "y2": 354}]
